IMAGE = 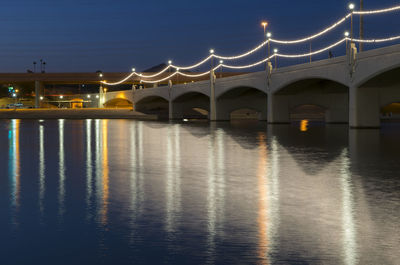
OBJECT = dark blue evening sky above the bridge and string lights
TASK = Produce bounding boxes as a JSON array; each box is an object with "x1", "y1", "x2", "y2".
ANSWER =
[{"x1": 0, "y1": 0, "x2": 400, "y2": 72}]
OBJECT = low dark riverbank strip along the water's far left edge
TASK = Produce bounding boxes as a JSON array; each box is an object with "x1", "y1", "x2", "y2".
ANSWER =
[{"x1": 0, "y1": 108, "x2": 158, "y2": 120}]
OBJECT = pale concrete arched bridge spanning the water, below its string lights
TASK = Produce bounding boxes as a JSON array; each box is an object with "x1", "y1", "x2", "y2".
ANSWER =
[{"x1": 126, "y1": 45, "x2": 400, "y2": 128}]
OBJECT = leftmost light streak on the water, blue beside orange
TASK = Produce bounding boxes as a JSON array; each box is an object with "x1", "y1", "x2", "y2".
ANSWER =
[{"x1": 8, "y1": 120, "x2": 21, "y2": 224}]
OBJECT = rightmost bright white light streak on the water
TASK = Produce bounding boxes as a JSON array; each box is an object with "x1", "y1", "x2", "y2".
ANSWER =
[{"x1": 340, "y1": 149, "x2": 357, "y2": 265}]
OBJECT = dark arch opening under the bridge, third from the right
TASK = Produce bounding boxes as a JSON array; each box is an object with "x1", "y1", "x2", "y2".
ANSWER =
[{"x1": 216, "y1": 86, "x2": 268, "y2": 121}]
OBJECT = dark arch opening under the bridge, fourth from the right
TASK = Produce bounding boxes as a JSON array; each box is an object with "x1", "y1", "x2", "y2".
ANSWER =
[{"x1": 170, "y1": 91, "x2": 210, "y2": 119}]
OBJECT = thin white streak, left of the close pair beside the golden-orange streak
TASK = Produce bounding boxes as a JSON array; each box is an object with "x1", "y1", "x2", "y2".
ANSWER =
[{"x1": 86, "y1": 120, "x2": 93, "y2": 217}]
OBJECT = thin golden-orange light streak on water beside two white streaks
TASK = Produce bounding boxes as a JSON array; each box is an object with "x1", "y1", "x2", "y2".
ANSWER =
[{"x1": 101, "y1": 120, "x2": 110, "y2": 225}]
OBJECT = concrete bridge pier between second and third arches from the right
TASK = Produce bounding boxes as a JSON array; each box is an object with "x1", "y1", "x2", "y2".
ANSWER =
[{"x1": 267, "y1": 93, "x2": 290, "y2": 123}]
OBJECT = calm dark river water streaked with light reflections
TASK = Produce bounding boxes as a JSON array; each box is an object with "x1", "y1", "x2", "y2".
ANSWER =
[{"x1": 0, "y1": 120, "x2": 400, "y2": 265}]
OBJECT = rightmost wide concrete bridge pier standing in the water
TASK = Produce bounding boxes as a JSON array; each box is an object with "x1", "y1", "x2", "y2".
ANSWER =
[{"x1": 349, "y1": 87, "x2": 380, "y2": 129}]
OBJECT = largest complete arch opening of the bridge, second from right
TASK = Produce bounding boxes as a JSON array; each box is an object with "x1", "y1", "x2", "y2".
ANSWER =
[{"x1": 269, "y1": 77, "x2": 349, "y2": 123}]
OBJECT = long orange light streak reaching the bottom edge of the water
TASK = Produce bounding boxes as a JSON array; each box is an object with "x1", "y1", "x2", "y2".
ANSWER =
[{"x1": 257, "y1": 133, "x2": 269, "y2": 264}]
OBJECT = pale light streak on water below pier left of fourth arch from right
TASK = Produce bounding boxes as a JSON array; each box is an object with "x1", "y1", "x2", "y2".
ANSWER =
[{"x1": 166, "y1": 125, "x2": 181, "y2": 233}]
